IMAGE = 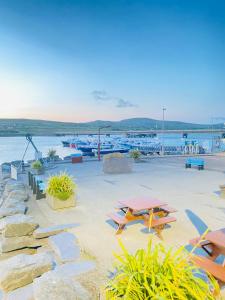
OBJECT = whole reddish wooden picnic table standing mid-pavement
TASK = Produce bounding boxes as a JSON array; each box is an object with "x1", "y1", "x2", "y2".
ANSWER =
[{"x1": 109, "y1": 197, "x2": 176, "y2": 235}]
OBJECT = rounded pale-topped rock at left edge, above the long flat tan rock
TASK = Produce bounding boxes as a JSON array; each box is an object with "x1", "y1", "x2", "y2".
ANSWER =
[{"x1": 0, "y1": 214, "x2": 38, "y2": 237}]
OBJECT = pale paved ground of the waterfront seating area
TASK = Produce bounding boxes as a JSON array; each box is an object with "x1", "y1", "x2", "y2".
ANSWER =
[{"x1": 24, "y1": 157, "x2": 225, "y2": 290}]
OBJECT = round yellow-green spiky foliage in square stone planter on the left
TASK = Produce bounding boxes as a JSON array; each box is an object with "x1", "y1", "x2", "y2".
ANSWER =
[{"x1": 46, "y1": 173, "x2": 76, "y2": 201}]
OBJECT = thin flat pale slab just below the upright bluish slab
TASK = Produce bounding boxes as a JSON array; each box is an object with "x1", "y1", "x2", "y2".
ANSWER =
[{"x1": 53, "y1": 261, "x2": 95, "y2": 277}]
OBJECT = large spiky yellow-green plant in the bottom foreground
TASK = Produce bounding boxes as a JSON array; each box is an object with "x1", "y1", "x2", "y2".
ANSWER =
[{"x1": 106, "y1": 241, "x2": 219, "y2": 300}]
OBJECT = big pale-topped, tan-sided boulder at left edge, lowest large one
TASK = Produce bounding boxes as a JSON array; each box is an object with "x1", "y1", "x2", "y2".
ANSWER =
[{"x1": 0, "y1": 253, "x2": 53, "y2": 292}]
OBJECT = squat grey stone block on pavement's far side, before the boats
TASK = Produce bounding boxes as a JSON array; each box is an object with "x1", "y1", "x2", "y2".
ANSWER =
[{"x1": 103, "y1": 156, "x2": 133, "y2": 174}]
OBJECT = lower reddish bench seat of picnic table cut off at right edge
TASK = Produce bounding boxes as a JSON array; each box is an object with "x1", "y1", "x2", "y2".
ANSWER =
[{"x1": 191, "y1": 256, "x2": 225, "y2": 284}]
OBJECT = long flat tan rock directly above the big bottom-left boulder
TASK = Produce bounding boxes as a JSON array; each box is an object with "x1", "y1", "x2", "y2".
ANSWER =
[{"x1": 0, "y1": 236, "x2": 42, "y2": 253}]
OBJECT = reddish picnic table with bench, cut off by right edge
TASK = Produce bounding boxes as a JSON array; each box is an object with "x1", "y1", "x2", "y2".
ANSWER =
[{"x1": 190, "y1": 228, "x2": 225, "y2": 286}]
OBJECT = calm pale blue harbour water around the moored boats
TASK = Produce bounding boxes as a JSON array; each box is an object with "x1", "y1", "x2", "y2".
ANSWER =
[{"x1": 0, "y1": 134, "x2": 225, "y2": 163}]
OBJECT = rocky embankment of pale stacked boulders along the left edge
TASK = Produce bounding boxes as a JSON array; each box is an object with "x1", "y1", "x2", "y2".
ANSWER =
[{"x1": 0, "y1": 170, "x2": 95, "y2": 300}]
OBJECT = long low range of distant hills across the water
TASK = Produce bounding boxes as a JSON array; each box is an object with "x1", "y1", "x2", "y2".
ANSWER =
[{"x1": 0, "y1": 118, "x2": 224, "y2": 136}]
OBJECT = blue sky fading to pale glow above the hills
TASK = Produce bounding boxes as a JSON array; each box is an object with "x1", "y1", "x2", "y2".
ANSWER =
[{"x1": 0, "y1": 0, "x2": 225, "y2": 123}]
